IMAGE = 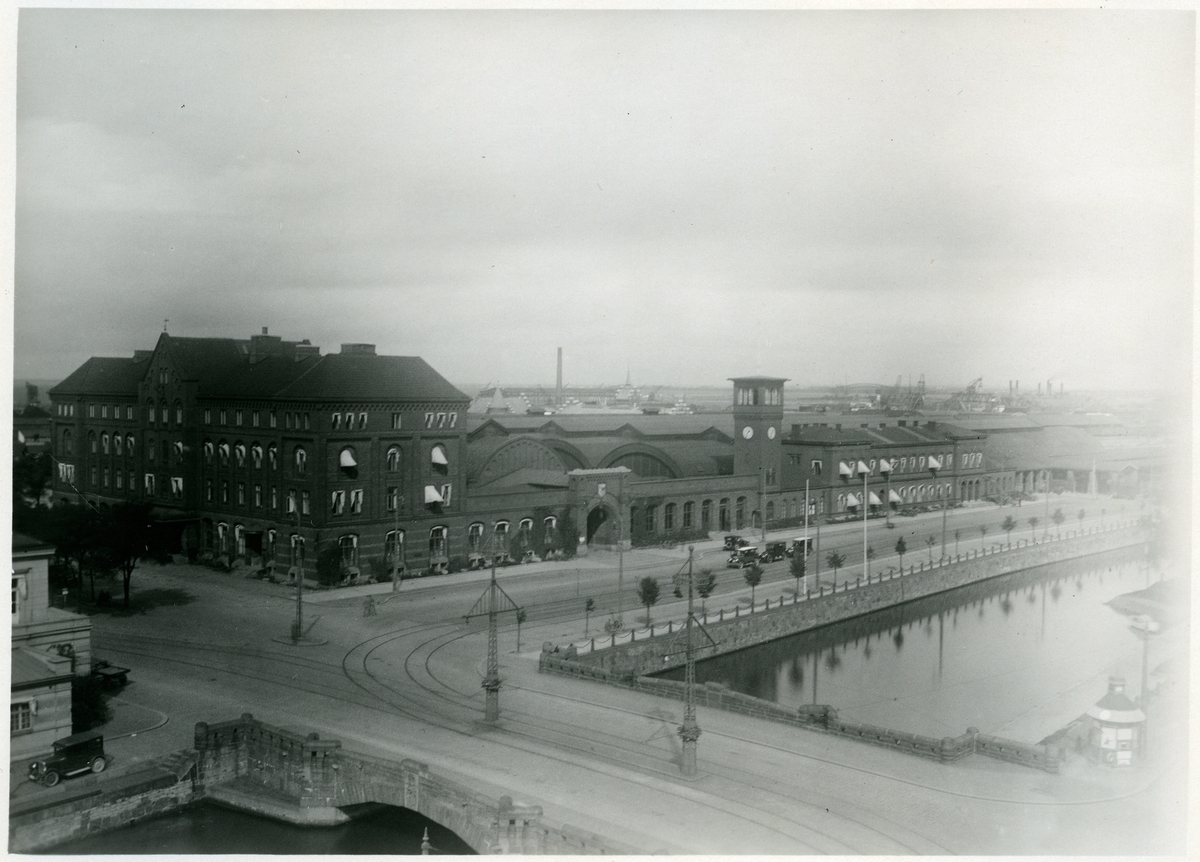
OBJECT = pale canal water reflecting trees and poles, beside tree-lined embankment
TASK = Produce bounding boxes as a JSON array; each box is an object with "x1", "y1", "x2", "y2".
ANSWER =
[{"x1": 661, "y1": 549, "x2": 1162, "y2": 743}]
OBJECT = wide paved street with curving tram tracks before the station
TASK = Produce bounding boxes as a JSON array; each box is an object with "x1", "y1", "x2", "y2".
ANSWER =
[{"x1": 25, "y1": 492, "x2": 1184, "y2": 855}]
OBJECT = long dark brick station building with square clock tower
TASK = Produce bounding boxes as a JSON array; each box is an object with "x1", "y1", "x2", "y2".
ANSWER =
[{"x1": 49, "y1": 329, "x2": 984, "y2": 577}]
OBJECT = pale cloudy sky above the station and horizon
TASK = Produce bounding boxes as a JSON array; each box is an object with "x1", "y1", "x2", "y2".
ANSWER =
[{"x1": 13, "y1": 8, "x2": 1195, "y2": 389}]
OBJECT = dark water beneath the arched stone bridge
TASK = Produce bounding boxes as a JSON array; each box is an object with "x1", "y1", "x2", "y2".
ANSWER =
[{"x1": 46, "y1": 802, "x2": 475, "y2": 856}]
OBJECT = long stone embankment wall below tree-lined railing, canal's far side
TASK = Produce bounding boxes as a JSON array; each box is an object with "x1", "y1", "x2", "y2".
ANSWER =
[{"x1": 544, "y1": 523, "x2": 1145, "y2": 678}]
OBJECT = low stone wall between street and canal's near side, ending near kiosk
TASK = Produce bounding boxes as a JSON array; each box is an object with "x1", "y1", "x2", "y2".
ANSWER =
[{"x1": 540, "y1": 653, "x2": 1061, "y2": 772}]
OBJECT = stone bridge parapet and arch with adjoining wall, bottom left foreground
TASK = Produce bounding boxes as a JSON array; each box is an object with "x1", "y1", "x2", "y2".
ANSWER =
[{"x1": 8, "y1": 713, "x2": 640, "y2": 855}]
